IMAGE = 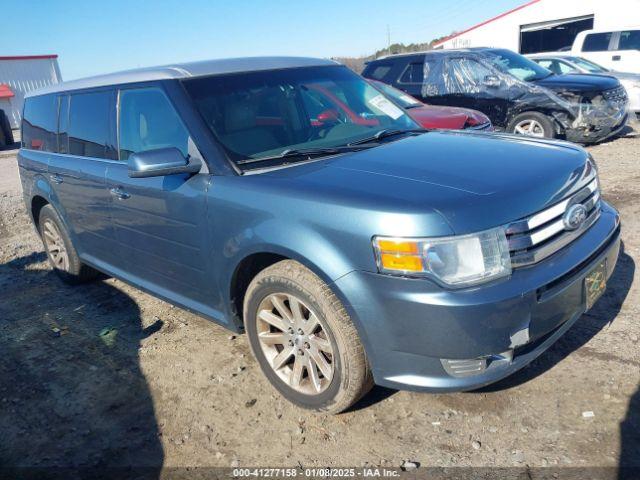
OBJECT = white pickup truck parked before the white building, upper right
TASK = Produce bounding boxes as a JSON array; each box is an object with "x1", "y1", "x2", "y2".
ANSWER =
[{"x1": 571, "y1": 26, "x2": 640, "y2": 73}]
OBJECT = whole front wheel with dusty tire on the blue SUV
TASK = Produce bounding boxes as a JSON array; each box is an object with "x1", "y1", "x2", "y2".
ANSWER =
[{"x1": 243, "y1": 260, "x2": 373, "y2": 414}]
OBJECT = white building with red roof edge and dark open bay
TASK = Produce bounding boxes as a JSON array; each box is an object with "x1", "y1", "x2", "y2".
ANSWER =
[{"x1": 434, "y1": 0, "x2": 640, "y2": 53}]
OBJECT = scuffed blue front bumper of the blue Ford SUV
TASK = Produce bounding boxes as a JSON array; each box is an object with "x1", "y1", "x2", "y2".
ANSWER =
[{"x1": 334, "y1": 202, "x2": 620, "y2": 391}]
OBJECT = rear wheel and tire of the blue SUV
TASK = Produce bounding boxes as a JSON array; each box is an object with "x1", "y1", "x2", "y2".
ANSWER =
[{"x1": 38, "y1": 205, "x2": 98, "y2": 285}]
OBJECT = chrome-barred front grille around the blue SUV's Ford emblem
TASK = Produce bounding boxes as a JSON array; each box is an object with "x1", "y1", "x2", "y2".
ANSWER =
[{"x1": 506, "y1": 178, "x2": 600, "y2": 268}]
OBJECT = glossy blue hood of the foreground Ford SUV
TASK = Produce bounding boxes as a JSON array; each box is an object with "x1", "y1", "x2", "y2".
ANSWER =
[{"x1": 263, "y1": 132, "x2": 587, "y2": 235}]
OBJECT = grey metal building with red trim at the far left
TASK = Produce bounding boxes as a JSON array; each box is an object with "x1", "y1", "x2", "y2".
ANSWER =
[{"x1": 0, "y1": 55, "x2": 62, "y2": 129}]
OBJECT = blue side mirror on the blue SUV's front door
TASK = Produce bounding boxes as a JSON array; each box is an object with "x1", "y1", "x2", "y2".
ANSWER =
[{"x1": 127, "y1": 147, "x2": 202, "y2": 178}]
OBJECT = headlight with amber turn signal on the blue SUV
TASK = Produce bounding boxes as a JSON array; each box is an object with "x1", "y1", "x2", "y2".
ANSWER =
[{"x1": 373, "y1": 227, "x2": 511, "y2": 287}]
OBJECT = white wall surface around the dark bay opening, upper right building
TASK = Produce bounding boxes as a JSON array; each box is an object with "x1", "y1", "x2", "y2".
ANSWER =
[{"x1": 436, "y1": 0, "x2": 640, "y2": 52}]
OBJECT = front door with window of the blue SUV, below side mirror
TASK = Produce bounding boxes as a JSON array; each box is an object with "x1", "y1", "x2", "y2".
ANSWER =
[{"x1": 106, "y1": 86, "x2": 212, "y2": 311}]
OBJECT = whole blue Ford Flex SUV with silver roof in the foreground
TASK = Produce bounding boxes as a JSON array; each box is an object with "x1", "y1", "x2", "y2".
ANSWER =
[{"x1": 18, "y1": 57, "x2": 620, "y2": 412}]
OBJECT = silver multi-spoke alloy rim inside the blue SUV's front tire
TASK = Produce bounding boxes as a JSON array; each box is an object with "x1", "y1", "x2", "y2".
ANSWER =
[{"x1": 256, "y1": 293, "x2": 335, "y2": 395}]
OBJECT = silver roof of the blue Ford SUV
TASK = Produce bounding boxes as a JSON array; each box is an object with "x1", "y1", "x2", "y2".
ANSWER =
[{"x1": 28, "y1": 57, "x2": 338, "y2": 96}]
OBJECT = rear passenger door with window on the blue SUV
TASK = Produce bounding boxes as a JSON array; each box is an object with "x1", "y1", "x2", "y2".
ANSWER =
[{"x1": 49, "y1": 89, "x2": 116, "y2": 264}]
